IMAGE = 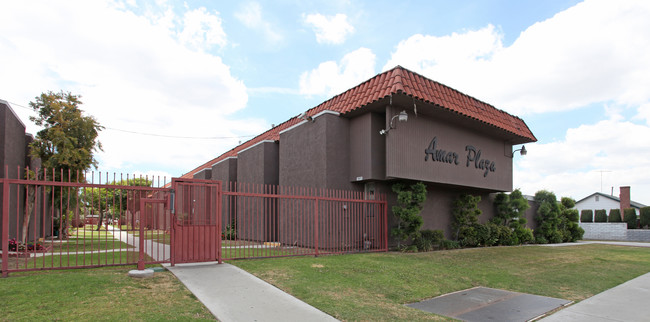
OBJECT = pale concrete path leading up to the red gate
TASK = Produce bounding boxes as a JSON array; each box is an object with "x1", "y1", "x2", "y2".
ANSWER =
[{"x1": 164, "y1": 262, "x2": 337, "y2": 322}]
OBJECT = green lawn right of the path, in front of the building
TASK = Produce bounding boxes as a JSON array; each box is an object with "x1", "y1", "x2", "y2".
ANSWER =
[{"x1": 231, "y1": 245, "x2": 650, "y2": 320}]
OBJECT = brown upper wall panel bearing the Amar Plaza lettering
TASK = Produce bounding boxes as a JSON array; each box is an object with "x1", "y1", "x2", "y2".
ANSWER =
[{"x1": 385, "y1": 106, "x2": 512, "y2": 191}]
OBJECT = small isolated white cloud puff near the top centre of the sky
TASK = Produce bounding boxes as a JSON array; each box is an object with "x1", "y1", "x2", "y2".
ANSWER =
[{"x1": 303, "y1": 13, "x2": 354, "y2": 45}]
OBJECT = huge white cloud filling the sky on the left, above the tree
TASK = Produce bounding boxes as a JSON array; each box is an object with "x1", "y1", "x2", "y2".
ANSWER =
[{"x1": 0, "y1": 1, "x2": 265, "y2": 175}]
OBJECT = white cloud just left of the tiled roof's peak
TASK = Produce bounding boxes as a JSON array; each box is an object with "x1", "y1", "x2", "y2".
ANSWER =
[{"x1": 300, "y1": 48, "x2": 375, "y2": 96}]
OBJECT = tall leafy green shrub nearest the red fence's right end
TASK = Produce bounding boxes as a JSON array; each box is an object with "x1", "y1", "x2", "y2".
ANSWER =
[{"x1": 392, "y1": 182, "x2": 427, "y2": 248}]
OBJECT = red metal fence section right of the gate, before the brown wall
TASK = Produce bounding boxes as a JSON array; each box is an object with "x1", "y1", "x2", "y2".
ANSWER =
[{"x1": 222, "y1": 183, "x2": 388, "y2": 259}]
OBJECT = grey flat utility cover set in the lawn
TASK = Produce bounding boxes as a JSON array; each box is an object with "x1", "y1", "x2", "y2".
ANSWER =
[{"x1": 406, "y1": 287, "x2": 571, "y2": 322}]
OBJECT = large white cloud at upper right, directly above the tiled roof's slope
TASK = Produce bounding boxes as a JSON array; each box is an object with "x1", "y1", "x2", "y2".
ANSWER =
[{"x1": 384, "y1": 0, "x2": 650, "y2": 114}]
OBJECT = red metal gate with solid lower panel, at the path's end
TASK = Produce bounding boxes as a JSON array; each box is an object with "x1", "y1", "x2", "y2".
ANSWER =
[{"x1": 171, "y1": 178, "x2": 221, "y2": 265}]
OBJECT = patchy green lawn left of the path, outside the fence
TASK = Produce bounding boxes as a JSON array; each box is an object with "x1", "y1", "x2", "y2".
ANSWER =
[{"x1": 0, "y1": 266, "x2": 214, "y2": 321}]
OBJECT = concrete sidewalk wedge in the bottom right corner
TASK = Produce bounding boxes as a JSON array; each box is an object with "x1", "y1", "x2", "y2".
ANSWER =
[{"x1": 541, "y1": 273, "x2": 650, "y2": 322}]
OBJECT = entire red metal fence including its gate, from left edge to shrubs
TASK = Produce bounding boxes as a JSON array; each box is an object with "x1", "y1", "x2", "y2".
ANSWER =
[{"x1": 0, "y1": 169, "x2": 388, "y2": 276}]
